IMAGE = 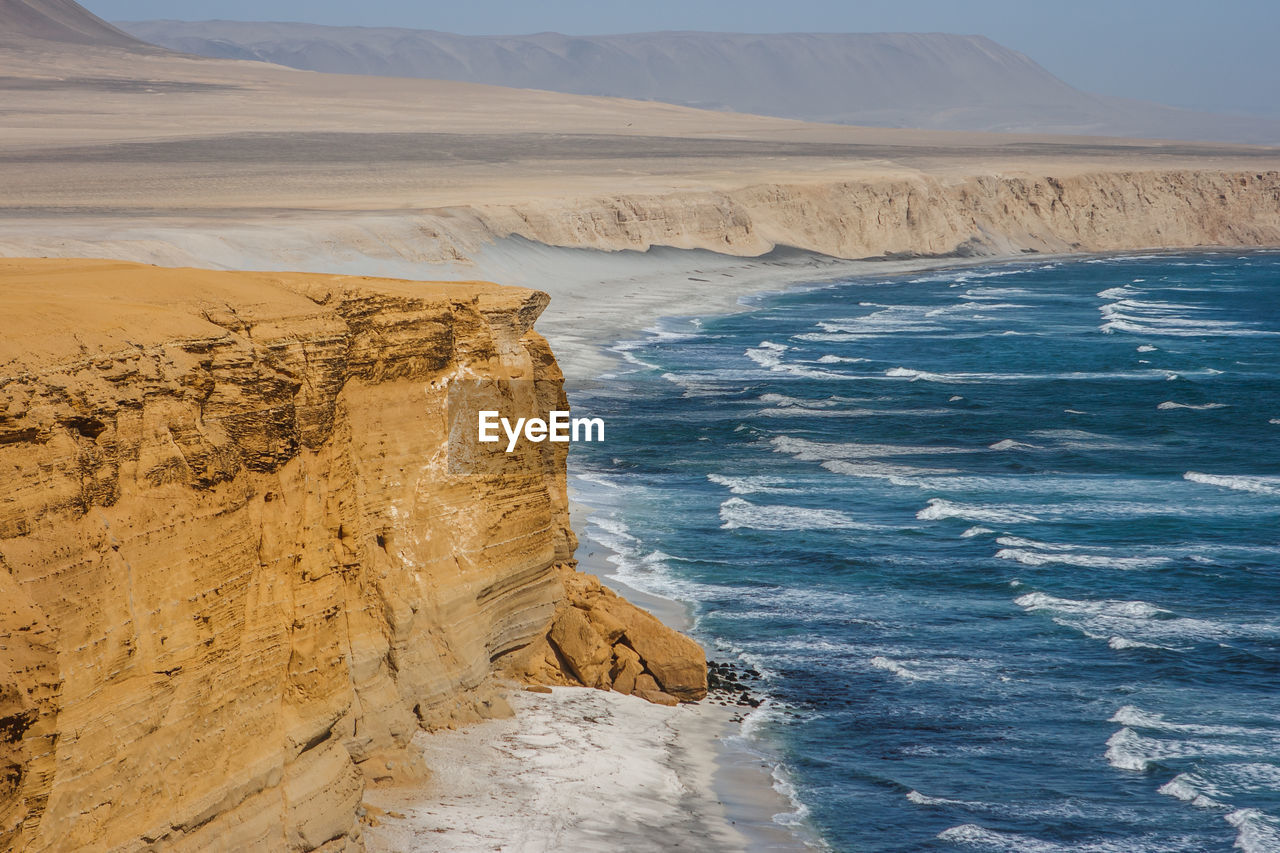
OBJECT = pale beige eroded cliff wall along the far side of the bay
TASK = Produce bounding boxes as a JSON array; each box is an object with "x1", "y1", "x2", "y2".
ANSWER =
[{"x1": 458, "y1": 169, "x2": 1280, "y2": 259}]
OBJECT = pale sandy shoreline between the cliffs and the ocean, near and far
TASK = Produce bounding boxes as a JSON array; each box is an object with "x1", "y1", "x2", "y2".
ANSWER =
[{"x1": 366, "y1": 241, "x2": 1249, "y2": 853}]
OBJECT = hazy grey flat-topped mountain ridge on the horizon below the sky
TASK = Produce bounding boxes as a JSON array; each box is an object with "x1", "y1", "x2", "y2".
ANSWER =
[{"x1": 119, "y1": 20, "x2": 1280, "y2": 142}]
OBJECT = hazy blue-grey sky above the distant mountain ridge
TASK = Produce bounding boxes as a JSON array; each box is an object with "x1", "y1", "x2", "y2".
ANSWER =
[{"x1": 82, "y1": 0, "x2": 1280, "y2": 115}]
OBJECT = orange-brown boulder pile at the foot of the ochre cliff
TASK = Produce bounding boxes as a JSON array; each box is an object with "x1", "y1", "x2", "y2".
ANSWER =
[{"x1": 508, "y1": 566, "x2": 707, "y2": 704}]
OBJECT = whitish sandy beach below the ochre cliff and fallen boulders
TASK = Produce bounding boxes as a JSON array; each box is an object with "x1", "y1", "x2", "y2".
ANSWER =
[{"x1": 365, "y1": 688, "x2": 801, "y2": 853}]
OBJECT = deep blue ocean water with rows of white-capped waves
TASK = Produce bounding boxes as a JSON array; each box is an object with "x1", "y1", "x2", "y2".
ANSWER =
[{"x1": 571, "y1": 252, "x2": 1280, "y2": 852}]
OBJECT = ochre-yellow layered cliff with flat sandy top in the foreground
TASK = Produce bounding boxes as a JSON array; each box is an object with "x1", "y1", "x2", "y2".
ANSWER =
[{"x1": 0, "y1": 260, "x2": 705, "y2": 850}]
